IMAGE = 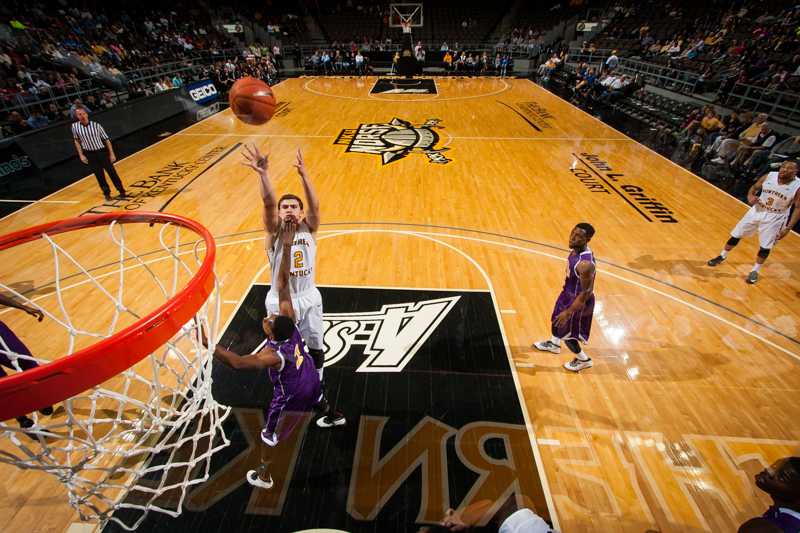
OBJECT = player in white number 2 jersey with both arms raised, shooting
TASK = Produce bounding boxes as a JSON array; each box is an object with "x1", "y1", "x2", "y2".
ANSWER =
[{"x1": 242, "y1": 144, "x2": 346, "y2": 427}]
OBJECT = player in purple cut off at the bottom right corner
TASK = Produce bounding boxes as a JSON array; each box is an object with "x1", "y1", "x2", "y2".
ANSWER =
[{"x1": 739, "y1": 457, "x2": 800, "y2": 533}]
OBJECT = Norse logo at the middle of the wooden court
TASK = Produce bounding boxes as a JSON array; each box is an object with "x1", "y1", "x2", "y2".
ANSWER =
[{"x1": 334, "y1": 118, "x2": 451, "y2": 165}]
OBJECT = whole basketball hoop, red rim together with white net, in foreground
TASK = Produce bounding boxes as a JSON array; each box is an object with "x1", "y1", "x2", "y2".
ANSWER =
[{"x1": 0, "y1": 212, "x2": 229, "y2": 530}]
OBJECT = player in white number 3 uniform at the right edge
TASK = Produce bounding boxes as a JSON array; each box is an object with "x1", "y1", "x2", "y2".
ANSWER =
[{"x1": 708, "y1": 161, "x2": 800, "y2": 284}]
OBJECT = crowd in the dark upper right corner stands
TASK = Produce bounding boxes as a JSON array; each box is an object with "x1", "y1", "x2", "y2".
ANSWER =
[{"x1": 585, "y1": 0, "x2": 800, "y2": 97}]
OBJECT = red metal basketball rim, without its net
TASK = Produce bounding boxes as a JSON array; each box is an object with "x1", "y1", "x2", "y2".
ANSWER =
[{"x1": 0, "y1": 212, "x2": 216, "y2": 420}]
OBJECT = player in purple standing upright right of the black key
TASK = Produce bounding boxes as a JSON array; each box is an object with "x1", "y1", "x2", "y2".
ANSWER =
[{"x1": 533, "y1": 222, "x2": 595, "y2": 372}]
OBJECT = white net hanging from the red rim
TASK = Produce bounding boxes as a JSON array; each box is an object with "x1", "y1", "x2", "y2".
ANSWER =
[{"x1": 0, "y1": 219, "x2": 229, "y2": 530}]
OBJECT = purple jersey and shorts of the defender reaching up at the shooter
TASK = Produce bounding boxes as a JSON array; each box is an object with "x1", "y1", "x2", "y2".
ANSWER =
[{"x1": 265, "y1": 327, "x2": 320, "y2": 435}]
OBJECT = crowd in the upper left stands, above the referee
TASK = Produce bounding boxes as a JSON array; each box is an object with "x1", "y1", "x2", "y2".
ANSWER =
[{"x1": 0, "y1": 0, "x2": 236, "y2": 134}]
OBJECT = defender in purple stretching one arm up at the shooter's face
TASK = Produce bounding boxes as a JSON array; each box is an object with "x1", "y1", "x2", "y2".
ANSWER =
[{"x1": 214, "y1": 221, "x2": 322, "y2": 489}]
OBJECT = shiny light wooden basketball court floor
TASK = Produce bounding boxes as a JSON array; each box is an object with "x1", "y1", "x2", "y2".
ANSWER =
[{"x1": 0, "y1": 78, "x2": 800, "y2": 532}]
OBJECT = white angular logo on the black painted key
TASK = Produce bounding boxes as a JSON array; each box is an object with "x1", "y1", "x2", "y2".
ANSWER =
[{"x1": 323, "y1": 296, "x2": 461, "y2": 372}]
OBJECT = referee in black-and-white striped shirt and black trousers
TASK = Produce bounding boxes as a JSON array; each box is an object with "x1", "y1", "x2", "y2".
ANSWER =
[{"x1": 72, "y1": 106, "x2": 125, "y2": 201}]
